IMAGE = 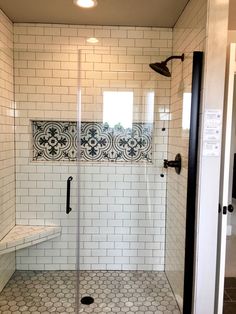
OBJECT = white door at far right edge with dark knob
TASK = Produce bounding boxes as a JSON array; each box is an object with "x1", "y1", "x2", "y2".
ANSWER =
[{"x1": 215, "y1": 44, "x2": 236, "y2": 314}]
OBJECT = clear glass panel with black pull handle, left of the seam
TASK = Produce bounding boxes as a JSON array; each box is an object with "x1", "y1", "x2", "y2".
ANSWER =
[{"x1": 0, "y1": 46, "x2": 78, "y2": 313}]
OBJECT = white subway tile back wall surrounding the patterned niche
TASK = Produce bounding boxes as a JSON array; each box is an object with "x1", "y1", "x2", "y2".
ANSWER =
[{"x1": 14, "y1": 24, "x2": 172, "y2": 270}]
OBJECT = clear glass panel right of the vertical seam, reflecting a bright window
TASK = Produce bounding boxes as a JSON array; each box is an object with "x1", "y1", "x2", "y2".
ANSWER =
[{"x1": 79, "y1": 48, "x2": 181, "y2": 313}]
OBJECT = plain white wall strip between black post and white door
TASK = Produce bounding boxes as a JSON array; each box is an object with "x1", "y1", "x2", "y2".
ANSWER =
[{"x1": 194, "y1": 0, "x2": 228, "y2": 314}]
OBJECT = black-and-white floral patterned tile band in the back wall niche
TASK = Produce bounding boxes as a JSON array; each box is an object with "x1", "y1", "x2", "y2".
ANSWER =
[{"x1": 32, "y1": 121, "x2": 152, "y2": 162}]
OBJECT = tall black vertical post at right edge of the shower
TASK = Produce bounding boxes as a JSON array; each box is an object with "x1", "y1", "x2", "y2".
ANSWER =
[{"x1": 183, "y1": 51, "x2": 203, "y2": 314}]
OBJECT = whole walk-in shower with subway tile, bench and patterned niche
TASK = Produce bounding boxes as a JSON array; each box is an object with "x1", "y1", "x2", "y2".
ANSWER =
[{"x1": 0, "y1": 25, "x2": 203, "y2": 314}]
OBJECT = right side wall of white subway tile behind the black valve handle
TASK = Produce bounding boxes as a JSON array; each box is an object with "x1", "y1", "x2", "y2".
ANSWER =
[{"x1": 165, "y1": 0, "x2": 207, "y2": 306}]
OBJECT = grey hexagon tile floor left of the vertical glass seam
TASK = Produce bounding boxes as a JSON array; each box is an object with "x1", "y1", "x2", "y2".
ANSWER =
[{"x1": 0, "y1": 271, "x2": 76, "y2": 314}]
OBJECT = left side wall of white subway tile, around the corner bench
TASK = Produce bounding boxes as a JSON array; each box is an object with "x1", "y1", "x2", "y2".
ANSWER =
[{"x1": 0, "y1": 10, "x2": 15, "y2": 291}]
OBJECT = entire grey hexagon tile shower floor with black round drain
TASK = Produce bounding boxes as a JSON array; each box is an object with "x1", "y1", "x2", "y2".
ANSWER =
[{"x1": 0, "y1": 271, "x2": 180, "y2": 314}]
